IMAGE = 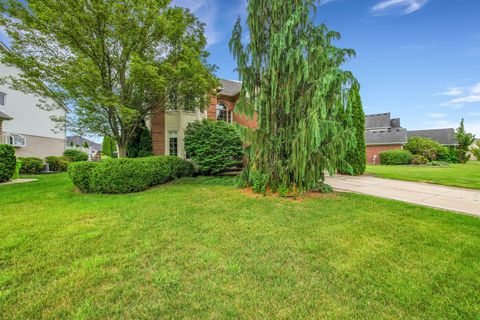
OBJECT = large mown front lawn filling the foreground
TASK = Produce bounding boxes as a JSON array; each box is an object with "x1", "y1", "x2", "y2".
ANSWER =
[{"x1": 0, "y1": 174, "x2": 480, "y2": 319}]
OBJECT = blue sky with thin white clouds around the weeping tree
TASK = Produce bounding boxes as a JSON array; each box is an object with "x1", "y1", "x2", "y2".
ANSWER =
[{"x1": 174, "y1": 0, "x2": 480, "y2": 137}]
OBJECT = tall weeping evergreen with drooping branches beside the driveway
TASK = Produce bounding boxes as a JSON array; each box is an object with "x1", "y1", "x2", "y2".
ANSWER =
[{"x1": 230, "y1": 0, "x2": 356, "y2": 192}]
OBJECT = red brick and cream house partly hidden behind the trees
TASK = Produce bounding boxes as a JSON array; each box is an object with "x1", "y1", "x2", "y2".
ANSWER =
[{"x1": 147, "y1": 79, "x2": 256, "y2": 158}]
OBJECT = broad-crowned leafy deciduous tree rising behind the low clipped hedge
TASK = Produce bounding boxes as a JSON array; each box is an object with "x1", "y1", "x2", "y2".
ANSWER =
[{"x1": 0, "y1": 0, "x2": 216, "y2": 157}]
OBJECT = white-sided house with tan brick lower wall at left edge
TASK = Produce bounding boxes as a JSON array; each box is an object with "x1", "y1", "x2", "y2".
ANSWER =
[{"x1": 0, "y1": 43, "x2": 68, "y2": 158}]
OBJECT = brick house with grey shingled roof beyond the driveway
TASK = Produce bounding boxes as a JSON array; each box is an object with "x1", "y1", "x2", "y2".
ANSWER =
[{"x1": 365, "y1": 113, "x2": 457, "y2": 164}]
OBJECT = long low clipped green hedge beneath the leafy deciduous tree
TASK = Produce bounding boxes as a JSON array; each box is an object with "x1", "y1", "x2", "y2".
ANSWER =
[{"x1": 69, "y1": 156, "x2": 193, "y2": 194}]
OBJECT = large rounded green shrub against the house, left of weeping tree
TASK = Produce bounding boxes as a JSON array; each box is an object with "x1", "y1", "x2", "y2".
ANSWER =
[{"x1": 184, "y1": 120, "x2": 244, "y2": 175}]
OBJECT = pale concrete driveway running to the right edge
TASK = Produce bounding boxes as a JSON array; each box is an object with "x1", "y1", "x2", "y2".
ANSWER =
[{"x1": 326, "y1": 175, "x2": 480, "y2": 217}]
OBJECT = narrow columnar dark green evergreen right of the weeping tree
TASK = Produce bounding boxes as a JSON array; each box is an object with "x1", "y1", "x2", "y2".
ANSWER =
[{"x1": 344, "y1": 83, "x2": 367, "y2": 176}]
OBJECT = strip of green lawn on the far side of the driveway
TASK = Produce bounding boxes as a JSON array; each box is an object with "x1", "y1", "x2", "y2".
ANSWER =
[{"x1": 367, "y1": 161, "x2": 480, "y2": 189}]
